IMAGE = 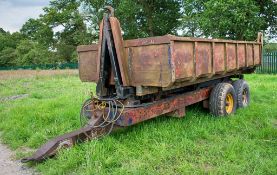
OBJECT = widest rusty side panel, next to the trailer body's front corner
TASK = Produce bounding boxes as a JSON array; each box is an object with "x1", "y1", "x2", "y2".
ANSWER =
[{"x1": 172, "y1": 41, "x2": 194, "y2": 80}]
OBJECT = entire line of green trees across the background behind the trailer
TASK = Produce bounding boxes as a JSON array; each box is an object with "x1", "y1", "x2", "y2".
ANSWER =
[{"x1": 0, "y1": 0, "x2": 277, "y2": 66}]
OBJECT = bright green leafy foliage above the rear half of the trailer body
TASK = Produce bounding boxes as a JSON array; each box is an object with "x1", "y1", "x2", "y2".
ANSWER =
[{"x1": 182, "y1": 0, "x2": 277, "y2": 40}]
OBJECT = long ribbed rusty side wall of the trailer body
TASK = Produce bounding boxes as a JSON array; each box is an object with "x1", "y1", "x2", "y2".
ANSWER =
[{"x1": 171, "y1": 40, "x2": 261, "y2": 83}]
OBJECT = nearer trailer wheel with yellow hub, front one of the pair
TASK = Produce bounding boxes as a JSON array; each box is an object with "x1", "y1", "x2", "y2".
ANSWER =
[{"x1": 209, "y1": 83, "x2": 237, "y2": 116}]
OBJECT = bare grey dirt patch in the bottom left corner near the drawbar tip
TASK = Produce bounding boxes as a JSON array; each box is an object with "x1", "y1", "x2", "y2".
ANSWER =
[{"x1": 0, "y1": 142, "x2": 35, "y2": 175}]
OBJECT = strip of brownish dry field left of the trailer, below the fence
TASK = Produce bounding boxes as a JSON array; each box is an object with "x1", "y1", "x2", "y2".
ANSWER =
[{"x1": 0, "y1": 69, "x2": 78, "y2": 80}]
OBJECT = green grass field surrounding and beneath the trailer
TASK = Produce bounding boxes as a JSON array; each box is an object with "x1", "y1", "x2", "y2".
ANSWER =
[{"x1": 0, "y1": 75, "x2": 277, "y2": 174}]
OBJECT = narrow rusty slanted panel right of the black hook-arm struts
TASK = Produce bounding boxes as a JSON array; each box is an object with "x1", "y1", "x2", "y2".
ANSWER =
[{"x1": 110, "y1": 17, "x2": 130, "y2": 86}]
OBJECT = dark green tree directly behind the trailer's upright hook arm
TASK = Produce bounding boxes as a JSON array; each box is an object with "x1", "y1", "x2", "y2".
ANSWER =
[{"x1": 83, "y1": 0, "x2": 181, "y2": 39}]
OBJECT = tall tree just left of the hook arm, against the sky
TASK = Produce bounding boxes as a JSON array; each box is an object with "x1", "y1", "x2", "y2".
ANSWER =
[{"x1": 42, "y1": 0, "x2": 92, "y2": 46}]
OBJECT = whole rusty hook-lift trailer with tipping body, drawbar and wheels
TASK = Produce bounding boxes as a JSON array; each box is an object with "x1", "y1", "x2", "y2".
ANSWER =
[{"x1": 22, "y1": 7, "x2": 263, "y2": 162}]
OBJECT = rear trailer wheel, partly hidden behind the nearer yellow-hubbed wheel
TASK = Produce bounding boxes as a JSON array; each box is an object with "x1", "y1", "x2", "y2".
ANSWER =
[{"x1": 233, "y1": 80, "x2": 250, "y2": 108}]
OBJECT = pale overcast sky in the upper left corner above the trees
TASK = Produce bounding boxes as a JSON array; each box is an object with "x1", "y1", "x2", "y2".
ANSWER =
[{"x1": 0, "y1": 0, "x2": 49, "y2": 32}]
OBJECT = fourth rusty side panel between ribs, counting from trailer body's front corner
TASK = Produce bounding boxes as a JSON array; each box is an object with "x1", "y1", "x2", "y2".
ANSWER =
[{"x1": 226, "y1": 43, "x2": 237, "y2": 72}]
